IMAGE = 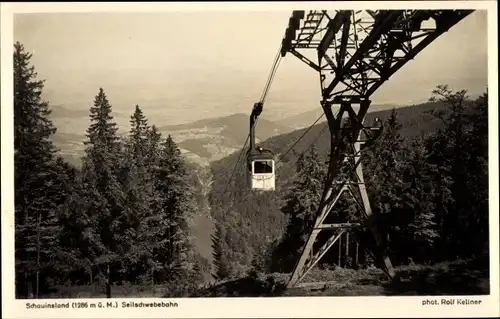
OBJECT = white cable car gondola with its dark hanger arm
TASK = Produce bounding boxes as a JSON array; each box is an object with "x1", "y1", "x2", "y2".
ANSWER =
[{"x1": 247, "y1": 103, "x2": 275, "y2": 191}]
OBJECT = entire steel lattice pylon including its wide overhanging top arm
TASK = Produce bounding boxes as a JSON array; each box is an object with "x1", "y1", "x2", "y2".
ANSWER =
[{"x1": 281, "y1": 10, "x2": 473, "y2": 287}]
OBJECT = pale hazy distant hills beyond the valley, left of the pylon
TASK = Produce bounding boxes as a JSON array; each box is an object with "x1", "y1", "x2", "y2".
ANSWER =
[{"x1": 51, "y1": 112, "x2": 293, "y2": 166}]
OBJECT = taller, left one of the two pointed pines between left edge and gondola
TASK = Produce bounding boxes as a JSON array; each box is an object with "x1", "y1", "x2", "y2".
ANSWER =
[{"x1": 83, "y1": 88, "x2": 124, "y2": 297}]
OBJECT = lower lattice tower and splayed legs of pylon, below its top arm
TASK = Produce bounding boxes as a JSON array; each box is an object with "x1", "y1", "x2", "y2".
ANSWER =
[{"x1": 287, "y1": 100, "x2": 395, "y2": 288}]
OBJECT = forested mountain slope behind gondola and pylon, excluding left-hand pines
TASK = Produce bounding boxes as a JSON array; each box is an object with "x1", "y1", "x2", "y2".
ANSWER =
[{"x1": 211, "y1": 87, "x2": 487, "y2": 290}]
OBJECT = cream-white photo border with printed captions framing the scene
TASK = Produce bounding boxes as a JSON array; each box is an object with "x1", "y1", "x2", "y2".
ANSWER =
[{"x1": 0, "y1": 1, "x2": 500, "y2": 318}]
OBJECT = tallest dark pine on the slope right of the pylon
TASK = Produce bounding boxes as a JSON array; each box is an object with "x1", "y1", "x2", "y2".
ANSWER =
[{"x1": 428, "y1": 85, "x2": 474, "y2": 256}]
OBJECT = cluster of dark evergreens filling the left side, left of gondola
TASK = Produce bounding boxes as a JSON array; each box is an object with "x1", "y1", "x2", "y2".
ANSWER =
[{"x1": 14, "y1": 43, "x2": 207, "y2": 298}]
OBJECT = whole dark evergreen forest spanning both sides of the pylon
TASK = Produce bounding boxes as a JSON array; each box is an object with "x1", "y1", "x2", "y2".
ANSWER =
[{"x1": 14, "y1": 39, "x2": 489, "y2": 298}]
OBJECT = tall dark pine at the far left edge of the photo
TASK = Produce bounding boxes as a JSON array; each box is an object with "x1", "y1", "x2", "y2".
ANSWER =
[{"x1": 14, "y1": 42, "x2": 59, "y2": 297}]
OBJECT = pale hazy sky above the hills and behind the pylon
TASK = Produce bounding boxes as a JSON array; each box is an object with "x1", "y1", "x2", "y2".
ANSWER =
[{"x1": 14, "y1": 11, "x2": 488, "y2": 131}]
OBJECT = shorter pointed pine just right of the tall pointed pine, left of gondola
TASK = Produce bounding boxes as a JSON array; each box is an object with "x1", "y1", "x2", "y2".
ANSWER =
[{"x1": 122, "y1": 105, "x2": 161, "y2": 284}]
